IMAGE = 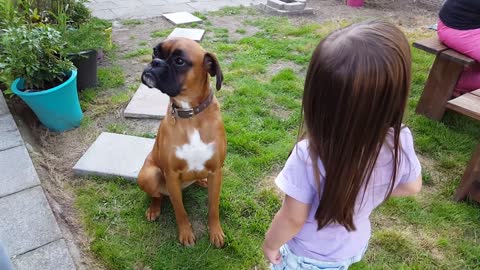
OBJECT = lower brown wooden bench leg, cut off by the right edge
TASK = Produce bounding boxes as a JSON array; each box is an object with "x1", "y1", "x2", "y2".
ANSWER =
[{"x1": 455, "y1": 143, "x2": 480, "y2": 202}]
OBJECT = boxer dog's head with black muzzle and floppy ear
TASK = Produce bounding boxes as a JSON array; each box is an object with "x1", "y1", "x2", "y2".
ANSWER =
[{"x1": 142, "y1": 38, "x2": 223, "y2": 97}]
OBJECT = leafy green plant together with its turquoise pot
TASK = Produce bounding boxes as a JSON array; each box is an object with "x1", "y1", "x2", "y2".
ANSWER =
[{"x1": 0, "y1": 25, "x2": 83, "y2": 131}]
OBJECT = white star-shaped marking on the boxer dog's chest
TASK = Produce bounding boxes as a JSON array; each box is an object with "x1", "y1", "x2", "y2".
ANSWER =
[{"x1": 175, "y1": 129, "x2": 215, "y2": 171}]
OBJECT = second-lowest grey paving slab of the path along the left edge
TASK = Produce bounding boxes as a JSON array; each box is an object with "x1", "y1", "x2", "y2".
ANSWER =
[{"x1": 0, "y1": 186, "x2": 62, "y2": 256}]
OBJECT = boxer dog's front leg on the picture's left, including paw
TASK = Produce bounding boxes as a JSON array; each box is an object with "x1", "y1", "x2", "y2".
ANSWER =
[{"x1": 166, "y1": 173, "x2": 195, "y2": 246}]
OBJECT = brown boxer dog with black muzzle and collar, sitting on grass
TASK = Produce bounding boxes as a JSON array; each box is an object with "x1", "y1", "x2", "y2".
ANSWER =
[{"x1": 138, "y1": 38, "x2": 227, "y2": 248}]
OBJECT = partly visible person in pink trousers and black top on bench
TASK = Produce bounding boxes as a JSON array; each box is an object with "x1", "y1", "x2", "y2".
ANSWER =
[{"x1": 437, "y1": 0, "x2": 480, "y2": 96}]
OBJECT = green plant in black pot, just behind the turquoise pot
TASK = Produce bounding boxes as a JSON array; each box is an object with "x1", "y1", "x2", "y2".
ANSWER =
[{"x1": 63, "y1": 19, "x2": 107, "y2": 91}]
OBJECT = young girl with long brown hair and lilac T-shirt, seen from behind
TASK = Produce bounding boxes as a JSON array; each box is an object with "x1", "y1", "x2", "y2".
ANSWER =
[{"x1": 263, "y1": 21, "x2": 422, "y2": 270}]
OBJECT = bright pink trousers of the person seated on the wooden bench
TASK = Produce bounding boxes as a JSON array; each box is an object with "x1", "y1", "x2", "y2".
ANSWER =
[{"x1": 437, "y1": 20, "x2": 480, "y2": 96}]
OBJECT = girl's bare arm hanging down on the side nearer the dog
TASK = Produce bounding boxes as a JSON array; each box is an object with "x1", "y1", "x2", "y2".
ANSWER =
[{"x1": 263, "y1": 195, "x2": 310, "y2": 264}]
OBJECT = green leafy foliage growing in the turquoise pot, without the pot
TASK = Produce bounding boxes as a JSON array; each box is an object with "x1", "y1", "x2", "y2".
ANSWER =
[{"x1": 0, "y1": 25, "x2": 73, "y2": 91}]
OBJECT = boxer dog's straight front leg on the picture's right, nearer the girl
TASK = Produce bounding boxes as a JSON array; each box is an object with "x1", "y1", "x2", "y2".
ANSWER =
[{"x1": 208, "y1": 168, "x2": 225, "y2": 248}]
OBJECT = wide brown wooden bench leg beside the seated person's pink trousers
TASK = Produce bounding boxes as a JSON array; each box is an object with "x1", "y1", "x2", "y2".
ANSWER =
[{"x1": 416, "y1": 55, "x2": 463, "y2": 120}]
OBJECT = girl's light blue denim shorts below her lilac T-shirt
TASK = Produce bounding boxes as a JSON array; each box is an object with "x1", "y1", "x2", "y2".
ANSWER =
[{"x1": 270, "y1": 244, "x2": 367, "y2": 270}]
